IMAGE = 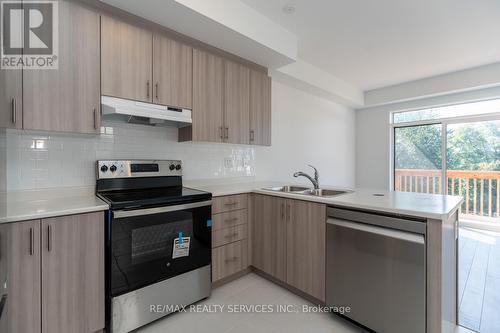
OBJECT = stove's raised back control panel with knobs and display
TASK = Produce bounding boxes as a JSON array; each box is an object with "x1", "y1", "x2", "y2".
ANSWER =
[{"x1": 96, "y1": 160, "x2": 182, "y2": 179}]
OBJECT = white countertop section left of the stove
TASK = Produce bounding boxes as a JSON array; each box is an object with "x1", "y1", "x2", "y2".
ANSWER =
[{"x1": 0, "y1": 188, "x2": 109, "y2": 223}]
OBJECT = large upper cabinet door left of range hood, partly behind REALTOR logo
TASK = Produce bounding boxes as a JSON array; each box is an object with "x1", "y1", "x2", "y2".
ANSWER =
[{"x1": 23, "y1": 1, "x2": 100, "y2": 133}]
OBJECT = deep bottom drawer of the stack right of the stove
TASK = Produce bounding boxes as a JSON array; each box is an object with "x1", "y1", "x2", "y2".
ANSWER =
[{"x1": 212, "y1": 239, "x2": 248, "y2": 282}]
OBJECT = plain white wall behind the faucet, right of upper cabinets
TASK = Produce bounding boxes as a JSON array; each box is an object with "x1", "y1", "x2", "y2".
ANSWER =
[{"x1": 256, "y1": 80, "x2": 355, "y2": 187}]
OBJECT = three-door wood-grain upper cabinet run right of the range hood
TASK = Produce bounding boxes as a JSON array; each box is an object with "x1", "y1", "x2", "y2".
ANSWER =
[{"x1": 179, "y1": 50, "x2": 271, "y2": 145}]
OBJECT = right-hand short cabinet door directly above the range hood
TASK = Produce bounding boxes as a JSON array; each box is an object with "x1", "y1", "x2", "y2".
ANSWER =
[{"x1": 153, "y1": 35, "x2": 193, "y2": 109}]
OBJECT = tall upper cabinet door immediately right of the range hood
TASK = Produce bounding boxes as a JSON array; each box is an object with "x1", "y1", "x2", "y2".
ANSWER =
[{"x1": 192, "y1": 49, "x2": 224, "y2": 142}]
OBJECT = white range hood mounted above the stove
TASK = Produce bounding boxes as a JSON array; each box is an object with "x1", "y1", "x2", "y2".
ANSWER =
[{"x1": 101, "y1": 96, "x2": 193, "y2": 127}]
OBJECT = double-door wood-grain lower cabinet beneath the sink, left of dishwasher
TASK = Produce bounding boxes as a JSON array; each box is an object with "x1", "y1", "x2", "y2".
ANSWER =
[{"x1": 251, "y1": 194, "x2": 326, "y2": 301}]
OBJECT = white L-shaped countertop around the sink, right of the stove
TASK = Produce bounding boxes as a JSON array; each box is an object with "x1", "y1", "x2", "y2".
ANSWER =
[{"x1": 185, "y1": 181, "x2": 463, "y2": 220}]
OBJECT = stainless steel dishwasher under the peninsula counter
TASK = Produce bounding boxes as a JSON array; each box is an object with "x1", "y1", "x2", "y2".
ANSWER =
[{"x1": 326, "y1": 207, "x2": 426, "y2": 333}]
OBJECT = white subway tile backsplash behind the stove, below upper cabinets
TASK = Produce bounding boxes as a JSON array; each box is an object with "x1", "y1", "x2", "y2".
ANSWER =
[{"x1": 6, "y1": 122, "x2": 255, "y2": 190}]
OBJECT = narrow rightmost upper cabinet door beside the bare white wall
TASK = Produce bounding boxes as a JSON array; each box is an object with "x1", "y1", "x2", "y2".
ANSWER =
[{"x1": 250, "y1": 70, "x2": 271, "y2": 146}]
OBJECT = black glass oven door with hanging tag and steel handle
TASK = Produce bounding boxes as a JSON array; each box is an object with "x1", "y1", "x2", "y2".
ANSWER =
[{"x1": 108, "y1": 201, "x2": 212, "y2": 297}]
